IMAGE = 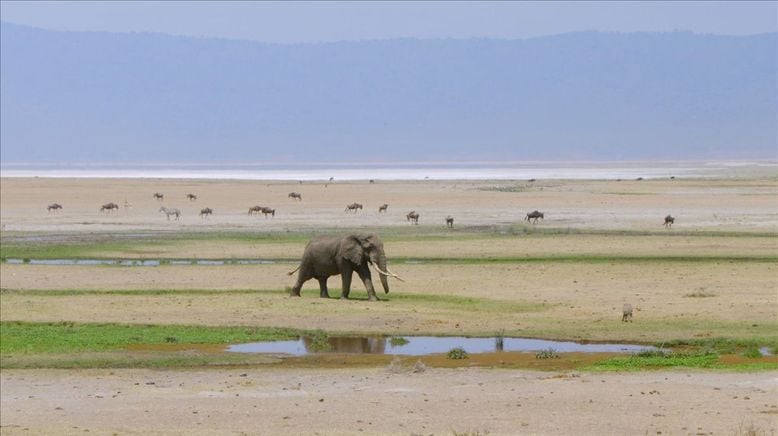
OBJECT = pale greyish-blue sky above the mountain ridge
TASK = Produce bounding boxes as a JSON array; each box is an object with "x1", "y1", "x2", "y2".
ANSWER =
[{"x1": 0, "y1": 0, "x2": 778, "y2": 43}]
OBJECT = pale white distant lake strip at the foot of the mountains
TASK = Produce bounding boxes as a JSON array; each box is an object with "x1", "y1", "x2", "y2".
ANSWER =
[{"x1": 0, "y1": 161, "x2": 778, "y2": 181}]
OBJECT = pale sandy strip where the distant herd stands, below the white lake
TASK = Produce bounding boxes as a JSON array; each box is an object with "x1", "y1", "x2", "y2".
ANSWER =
[{"x1": 0, "y1": 178, "x2": 778, "y2": 232}]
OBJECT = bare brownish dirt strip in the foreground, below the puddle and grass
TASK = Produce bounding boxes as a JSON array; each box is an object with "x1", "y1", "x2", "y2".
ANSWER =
[{"x1": 0, "y1": 368, "x2": 778, "y2": 435}]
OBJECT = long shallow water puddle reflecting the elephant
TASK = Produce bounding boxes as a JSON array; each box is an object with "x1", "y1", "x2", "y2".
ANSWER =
[{"x1": 227, "y1": 336, "x2": 655, "y2": 356}]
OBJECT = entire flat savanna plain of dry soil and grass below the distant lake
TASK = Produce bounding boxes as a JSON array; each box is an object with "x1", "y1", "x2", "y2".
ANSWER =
[{"x1": 0, "y1": 172, "x2": 778, "y2": 435}]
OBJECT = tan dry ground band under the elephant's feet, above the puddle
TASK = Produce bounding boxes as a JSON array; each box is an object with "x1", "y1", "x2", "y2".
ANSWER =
[{"x1": 0, "y1": 262, "x2": 778, "y2": 340}]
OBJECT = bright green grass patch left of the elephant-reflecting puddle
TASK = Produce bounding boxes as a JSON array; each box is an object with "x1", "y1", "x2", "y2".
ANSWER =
[{"x1": 0, "y1": 322, "x2": 302, "y2": 355}]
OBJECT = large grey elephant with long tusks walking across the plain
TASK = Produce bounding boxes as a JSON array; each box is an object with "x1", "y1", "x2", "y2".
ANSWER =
[{"x1": 288, "y1": 233, "x2": 402, "y2": 301}]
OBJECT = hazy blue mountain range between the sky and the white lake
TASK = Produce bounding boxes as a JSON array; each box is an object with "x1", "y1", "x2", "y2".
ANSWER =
[{"x1": 0, "y1": 23, "x2": 778, "y2": 163}]
